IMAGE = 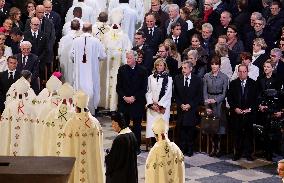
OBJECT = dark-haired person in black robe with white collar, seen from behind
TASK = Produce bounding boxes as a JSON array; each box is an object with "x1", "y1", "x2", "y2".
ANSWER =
[{"x1": 105, "y1": 112, "x2": 138, "y2": 183}]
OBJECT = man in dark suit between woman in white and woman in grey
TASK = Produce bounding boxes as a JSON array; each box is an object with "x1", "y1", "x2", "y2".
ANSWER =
[{"x1": 174, "y1": 61, "x2": 202, "y2": 156}]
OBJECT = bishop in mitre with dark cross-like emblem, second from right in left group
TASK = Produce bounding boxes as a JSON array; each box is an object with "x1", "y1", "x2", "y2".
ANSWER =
[{"x1": 41, "y1": 83, "x2": 74, "y2": 156}]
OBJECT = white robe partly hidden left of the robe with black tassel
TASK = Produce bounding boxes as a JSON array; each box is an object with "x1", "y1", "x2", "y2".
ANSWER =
[{"x1": 58, "y1": 30, "x2": 81, "y2": 83}]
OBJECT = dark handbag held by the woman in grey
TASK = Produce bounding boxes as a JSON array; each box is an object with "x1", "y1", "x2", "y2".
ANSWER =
[{"x1": 200, "y1": 114, "x2": 220, "y2": 134}]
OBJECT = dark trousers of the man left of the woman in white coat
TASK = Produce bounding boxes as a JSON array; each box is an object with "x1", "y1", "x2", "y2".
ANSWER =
[{"x1": 124, "y1": 114, "x2": 142, "y2": 149}]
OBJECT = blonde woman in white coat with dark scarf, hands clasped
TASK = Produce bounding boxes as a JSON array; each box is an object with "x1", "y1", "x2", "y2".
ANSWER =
[{"x1": 146, "y1": 58, "x2": 173, "y2": 138}]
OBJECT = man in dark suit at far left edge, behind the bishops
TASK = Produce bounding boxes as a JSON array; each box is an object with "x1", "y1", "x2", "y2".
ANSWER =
[{"x1": 0, "y1": 56, "x2": 20, "y2": 113}]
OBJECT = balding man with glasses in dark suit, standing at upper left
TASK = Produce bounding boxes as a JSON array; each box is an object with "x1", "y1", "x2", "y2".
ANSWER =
[{"x1": 24, "y1": 17, "x2": 50, "y2": 81}]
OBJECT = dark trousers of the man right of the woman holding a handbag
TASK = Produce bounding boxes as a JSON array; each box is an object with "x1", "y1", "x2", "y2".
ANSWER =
[{"x1": 232, "y1": 114, "x2": 253, "y2": 156}]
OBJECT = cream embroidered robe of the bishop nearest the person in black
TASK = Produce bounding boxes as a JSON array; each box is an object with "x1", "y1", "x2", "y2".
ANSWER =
[{"x1": 60, "y1": 112, "x2": 105, "y2": 183}]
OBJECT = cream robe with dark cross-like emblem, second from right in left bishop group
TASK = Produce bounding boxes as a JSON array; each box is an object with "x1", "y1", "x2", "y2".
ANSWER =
[{"x1": 38, "y1": 101, "x2": 75, "y2": 156}]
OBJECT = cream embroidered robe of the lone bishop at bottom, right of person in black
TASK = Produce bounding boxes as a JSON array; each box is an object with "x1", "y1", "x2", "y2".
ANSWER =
[{"x1": 145, "y1": 139, "x2": 185, "y2": 183}]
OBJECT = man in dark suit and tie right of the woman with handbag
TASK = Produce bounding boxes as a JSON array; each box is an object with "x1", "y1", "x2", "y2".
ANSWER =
[{"x1": 228, "y1": 64, "x2": 257, "y2": 161}]
